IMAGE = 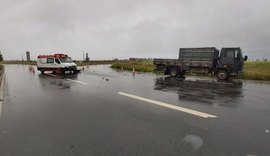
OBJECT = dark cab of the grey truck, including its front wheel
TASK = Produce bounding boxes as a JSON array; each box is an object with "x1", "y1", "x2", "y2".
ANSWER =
[{"x1": 215, "y1": 47, "x2": 247, "y2": 80}]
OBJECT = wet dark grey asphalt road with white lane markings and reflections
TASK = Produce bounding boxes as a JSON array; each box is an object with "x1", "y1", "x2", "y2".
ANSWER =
[{"x1": 0, "y1": 65, "x2": 270, "y2": 156}]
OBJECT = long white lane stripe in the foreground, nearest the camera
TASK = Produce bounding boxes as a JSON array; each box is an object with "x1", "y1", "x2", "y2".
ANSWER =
[{"x1": 118, "y1": 92, "x2": 217, "y2": 118}]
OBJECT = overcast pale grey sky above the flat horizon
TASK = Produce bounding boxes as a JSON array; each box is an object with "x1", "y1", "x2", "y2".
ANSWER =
[{"x1": 0, "y1": 0, "x2": 270, "y2": 60}]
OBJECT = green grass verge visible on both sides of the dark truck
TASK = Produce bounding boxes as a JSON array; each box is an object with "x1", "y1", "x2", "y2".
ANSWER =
[{"x1": 111, "y1": 61, "x2": 270, "y2": 81}]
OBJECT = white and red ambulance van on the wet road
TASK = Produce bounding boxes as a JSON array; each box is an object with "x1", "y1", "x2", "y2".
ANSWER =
[{"x1": 37, "y1": 54, "x2": 80, "y2": 74}]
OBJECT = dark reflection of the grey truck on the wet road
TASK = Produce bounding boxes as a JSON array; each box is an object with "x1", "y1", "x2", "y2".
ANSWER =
[{"x1": 155, "y1": 77, "x2": 243, "y2": 107}]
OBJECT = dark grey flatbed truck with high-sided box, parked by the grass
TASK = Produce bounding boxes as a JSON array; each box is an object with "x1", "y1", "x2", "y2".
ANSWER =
[{"x1": 154, "y1": 47, "x2": 248, "y2": 80}]
